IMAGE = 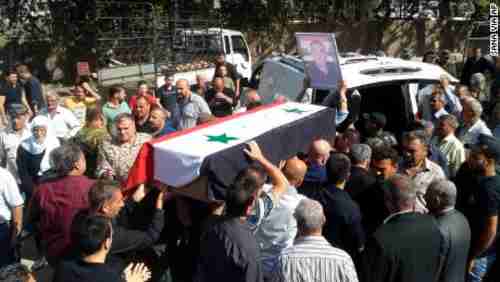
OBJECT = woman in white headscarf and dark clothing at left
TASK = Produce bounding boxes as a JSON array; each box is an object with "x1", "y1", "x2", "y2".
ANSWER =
[{"x1": 16, "y1": 116, "x2": 61, "y2": 199}]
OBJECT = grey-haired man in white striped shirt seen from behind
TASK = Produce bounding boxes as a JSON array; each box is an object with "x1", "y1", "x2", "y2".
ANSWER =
[{"x1": 271, "y1": 199, "x2": 358, "y2": 282}]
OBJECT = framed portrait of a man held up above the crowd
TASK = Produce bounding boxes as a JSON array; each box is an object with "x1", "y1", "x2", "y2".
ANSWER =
[{"x1": 295, "y1": 33, "x2": 342, "y2": 90}]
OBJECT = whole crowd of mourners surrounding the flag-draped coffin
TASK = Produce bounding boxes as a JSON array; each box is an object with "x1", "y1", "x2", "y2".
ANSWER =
[{"x1": 0, "y1": 50, "x2": 500, "y2": 282}]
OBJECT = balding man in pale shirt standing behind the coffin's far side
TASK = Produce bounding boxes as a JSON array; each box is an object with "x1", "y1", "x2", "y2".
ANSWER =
[{"x1": 174, "y1": 79, "x2": 212, "y2": 130}]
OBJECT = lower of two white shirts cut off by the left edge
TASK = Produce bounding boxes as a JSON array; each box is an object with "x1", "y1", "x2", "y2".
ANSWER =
[{"x1": 0, "y1": 167, "x2": 24, "y2": 223}]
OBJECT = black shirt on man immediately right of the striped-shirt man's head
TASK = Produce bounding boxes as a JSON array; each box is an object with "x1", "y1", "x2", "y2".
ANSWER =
[{"x1": 313, "y1": 186, "x2": 365, "y2": 257}]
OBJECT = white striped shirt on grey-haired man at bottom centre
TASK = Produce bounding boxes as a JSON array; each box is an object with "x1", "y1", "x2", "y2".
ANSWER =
[{"x1": 271, "y1": 236, "x2": 358, "y2": 282}]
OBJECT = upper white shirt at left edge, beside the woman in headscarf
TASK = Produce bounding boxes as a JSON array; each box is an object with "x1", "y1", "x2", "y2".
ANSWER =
[{"x1": 0, "y1": 126, "x2": 31, "y2": 183}]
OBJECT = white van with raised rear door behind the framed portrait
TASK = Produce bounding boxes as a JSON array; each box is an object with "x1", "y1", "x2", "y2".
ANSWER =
[{"x1": 250, "y1": 54, "x2": 458, "y2": 134}]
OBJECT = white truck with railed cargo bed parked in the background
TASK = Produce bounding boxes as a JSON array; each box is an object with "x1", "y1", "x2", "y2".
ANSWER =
[{"x1": 98, "y1": 28, "x2": 252, "y2": 87}]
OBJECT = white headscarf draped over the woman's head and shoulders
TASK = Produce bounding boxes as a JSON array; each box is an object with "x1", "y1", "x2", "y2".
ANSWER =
[{"x1": 21, "y1": 116, "x2": 61, "y2": 175}]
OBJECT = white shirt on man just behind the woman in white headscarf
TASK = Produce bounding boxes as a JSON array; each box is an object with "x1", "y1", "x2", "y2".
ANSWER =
[{"x1": 41, "y1": 106, "x2": 82, "y2": 140}]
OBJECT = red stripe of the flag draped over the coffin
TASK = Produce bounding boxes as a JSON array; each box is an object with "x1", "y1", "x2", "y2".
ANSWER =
[{"x1": 122, "y1": 102, "x2": 283, "y2": 194}]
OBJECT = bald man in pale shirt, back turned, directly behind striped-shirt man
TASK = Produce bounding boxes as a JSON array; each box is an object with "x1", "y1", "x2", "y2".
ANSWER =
[{"x1": 255, "y1": 158, "x2": 307, "y2": 278}]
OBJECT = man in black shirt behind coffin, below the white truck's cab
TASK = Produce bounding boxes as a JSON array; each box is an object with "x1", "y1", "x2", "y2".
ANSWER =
[{"x1": 205, "y1": 77, "x2": 236, "y2": 117}]
